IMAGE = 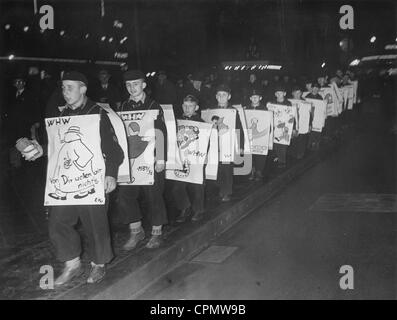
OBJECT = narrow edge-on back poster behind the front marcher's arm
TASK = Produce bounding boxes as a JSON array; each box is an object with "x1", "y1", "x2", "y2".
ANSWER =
[{"x1": 97, "y1": 102, "x2": 131, "y2": 182}]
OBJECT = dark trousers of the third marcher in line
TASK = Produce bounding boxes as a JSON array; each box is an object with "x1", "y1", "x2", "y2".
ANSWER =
[{"x1": 172, "y1": 181, "x2": 204, "y2": 213}]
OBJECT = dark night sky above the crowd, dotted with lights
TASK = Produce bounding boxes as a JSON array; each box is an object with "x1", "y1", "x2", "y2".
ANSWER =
[{"x1": 0, "y1": 0, "x2": 397, "y2": 76}]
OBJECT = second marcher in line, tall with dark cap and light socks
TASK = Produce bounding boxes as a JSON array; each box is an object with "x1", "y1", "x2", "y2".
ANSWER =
[{"x1": 118, "y1": 70, "x2": 168, "y2": 250}]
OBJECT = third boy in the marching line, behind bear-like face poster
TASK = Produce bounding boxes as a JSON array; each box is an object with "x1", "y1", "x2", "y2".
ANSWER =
[{"x1": 172, "y1": 95, "x2": 204, "y2": 222}]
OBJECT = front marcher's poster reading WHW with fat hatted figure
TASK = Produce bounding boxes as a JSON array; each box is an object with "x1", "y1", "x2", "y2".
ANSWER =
[{"x1": 44, "y1": 114, "x2": 105, "y2": 206}]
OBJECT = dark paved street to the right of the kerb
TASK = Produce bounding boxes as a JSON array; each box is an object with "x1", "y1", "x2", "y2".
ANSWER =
[{"x1": 135, "y1": 101, "x2": 397, "y2": 299}]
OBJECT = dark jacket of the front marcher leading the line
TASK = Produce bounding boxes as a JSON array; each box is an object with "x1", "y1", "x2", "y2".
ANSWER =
[{"x1": 58, "y1": 98, "x2": 124, "y2": 179}]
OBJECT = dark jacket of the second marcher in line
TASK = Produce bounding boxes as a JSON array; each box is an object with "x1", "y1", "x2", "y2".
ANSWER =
[{"x1": 118, "y1": 95, "x2": 167, "y2": 161}]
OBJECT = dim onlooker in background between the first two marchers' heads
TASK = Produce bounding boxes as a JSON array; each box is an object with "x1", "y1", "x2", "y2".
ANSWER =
[{"x1": 88, "y1": 69, "x2": 121, "y2": 110}]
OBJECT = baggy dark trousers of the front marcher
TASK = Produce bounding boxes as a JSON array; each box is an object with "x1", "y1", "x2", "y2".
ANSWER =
[{"x1": 48, "y1": 201, "x2": 113, "y2": 264}]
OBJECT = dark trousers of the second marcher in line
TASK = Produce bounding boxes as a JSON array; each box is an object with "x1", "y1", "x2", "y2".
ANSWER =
[{"x1": 117, "y1": 172, "x2": 168, "y2": 226}]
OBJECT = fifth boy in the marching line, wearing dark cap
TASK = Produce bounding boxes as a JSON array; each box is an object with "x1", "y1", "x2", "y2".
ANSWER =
[{"x1": 245, "y1": 88, "x2": 267, "y2": 181}]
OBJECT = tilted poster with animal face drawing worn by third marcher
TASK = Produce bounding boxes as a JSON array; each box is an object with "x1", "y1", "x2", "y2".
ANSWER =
[{"x1": 166, "y1": 120, "x2": 212, "y2": 184}]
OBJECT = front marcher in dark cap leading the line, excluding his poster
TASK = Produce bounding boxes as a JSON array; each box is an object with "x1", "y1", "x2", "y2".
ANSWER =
[{"x1": 34, "y1": 71, "x2": 123, "y2": 286}]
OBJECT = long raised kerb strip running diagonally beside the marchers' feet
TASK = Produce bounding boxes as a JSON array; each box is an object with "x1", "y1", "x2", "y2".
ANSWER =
[{"x1": 54, "y1": 144, "x2": 336, "y2": 300}]
